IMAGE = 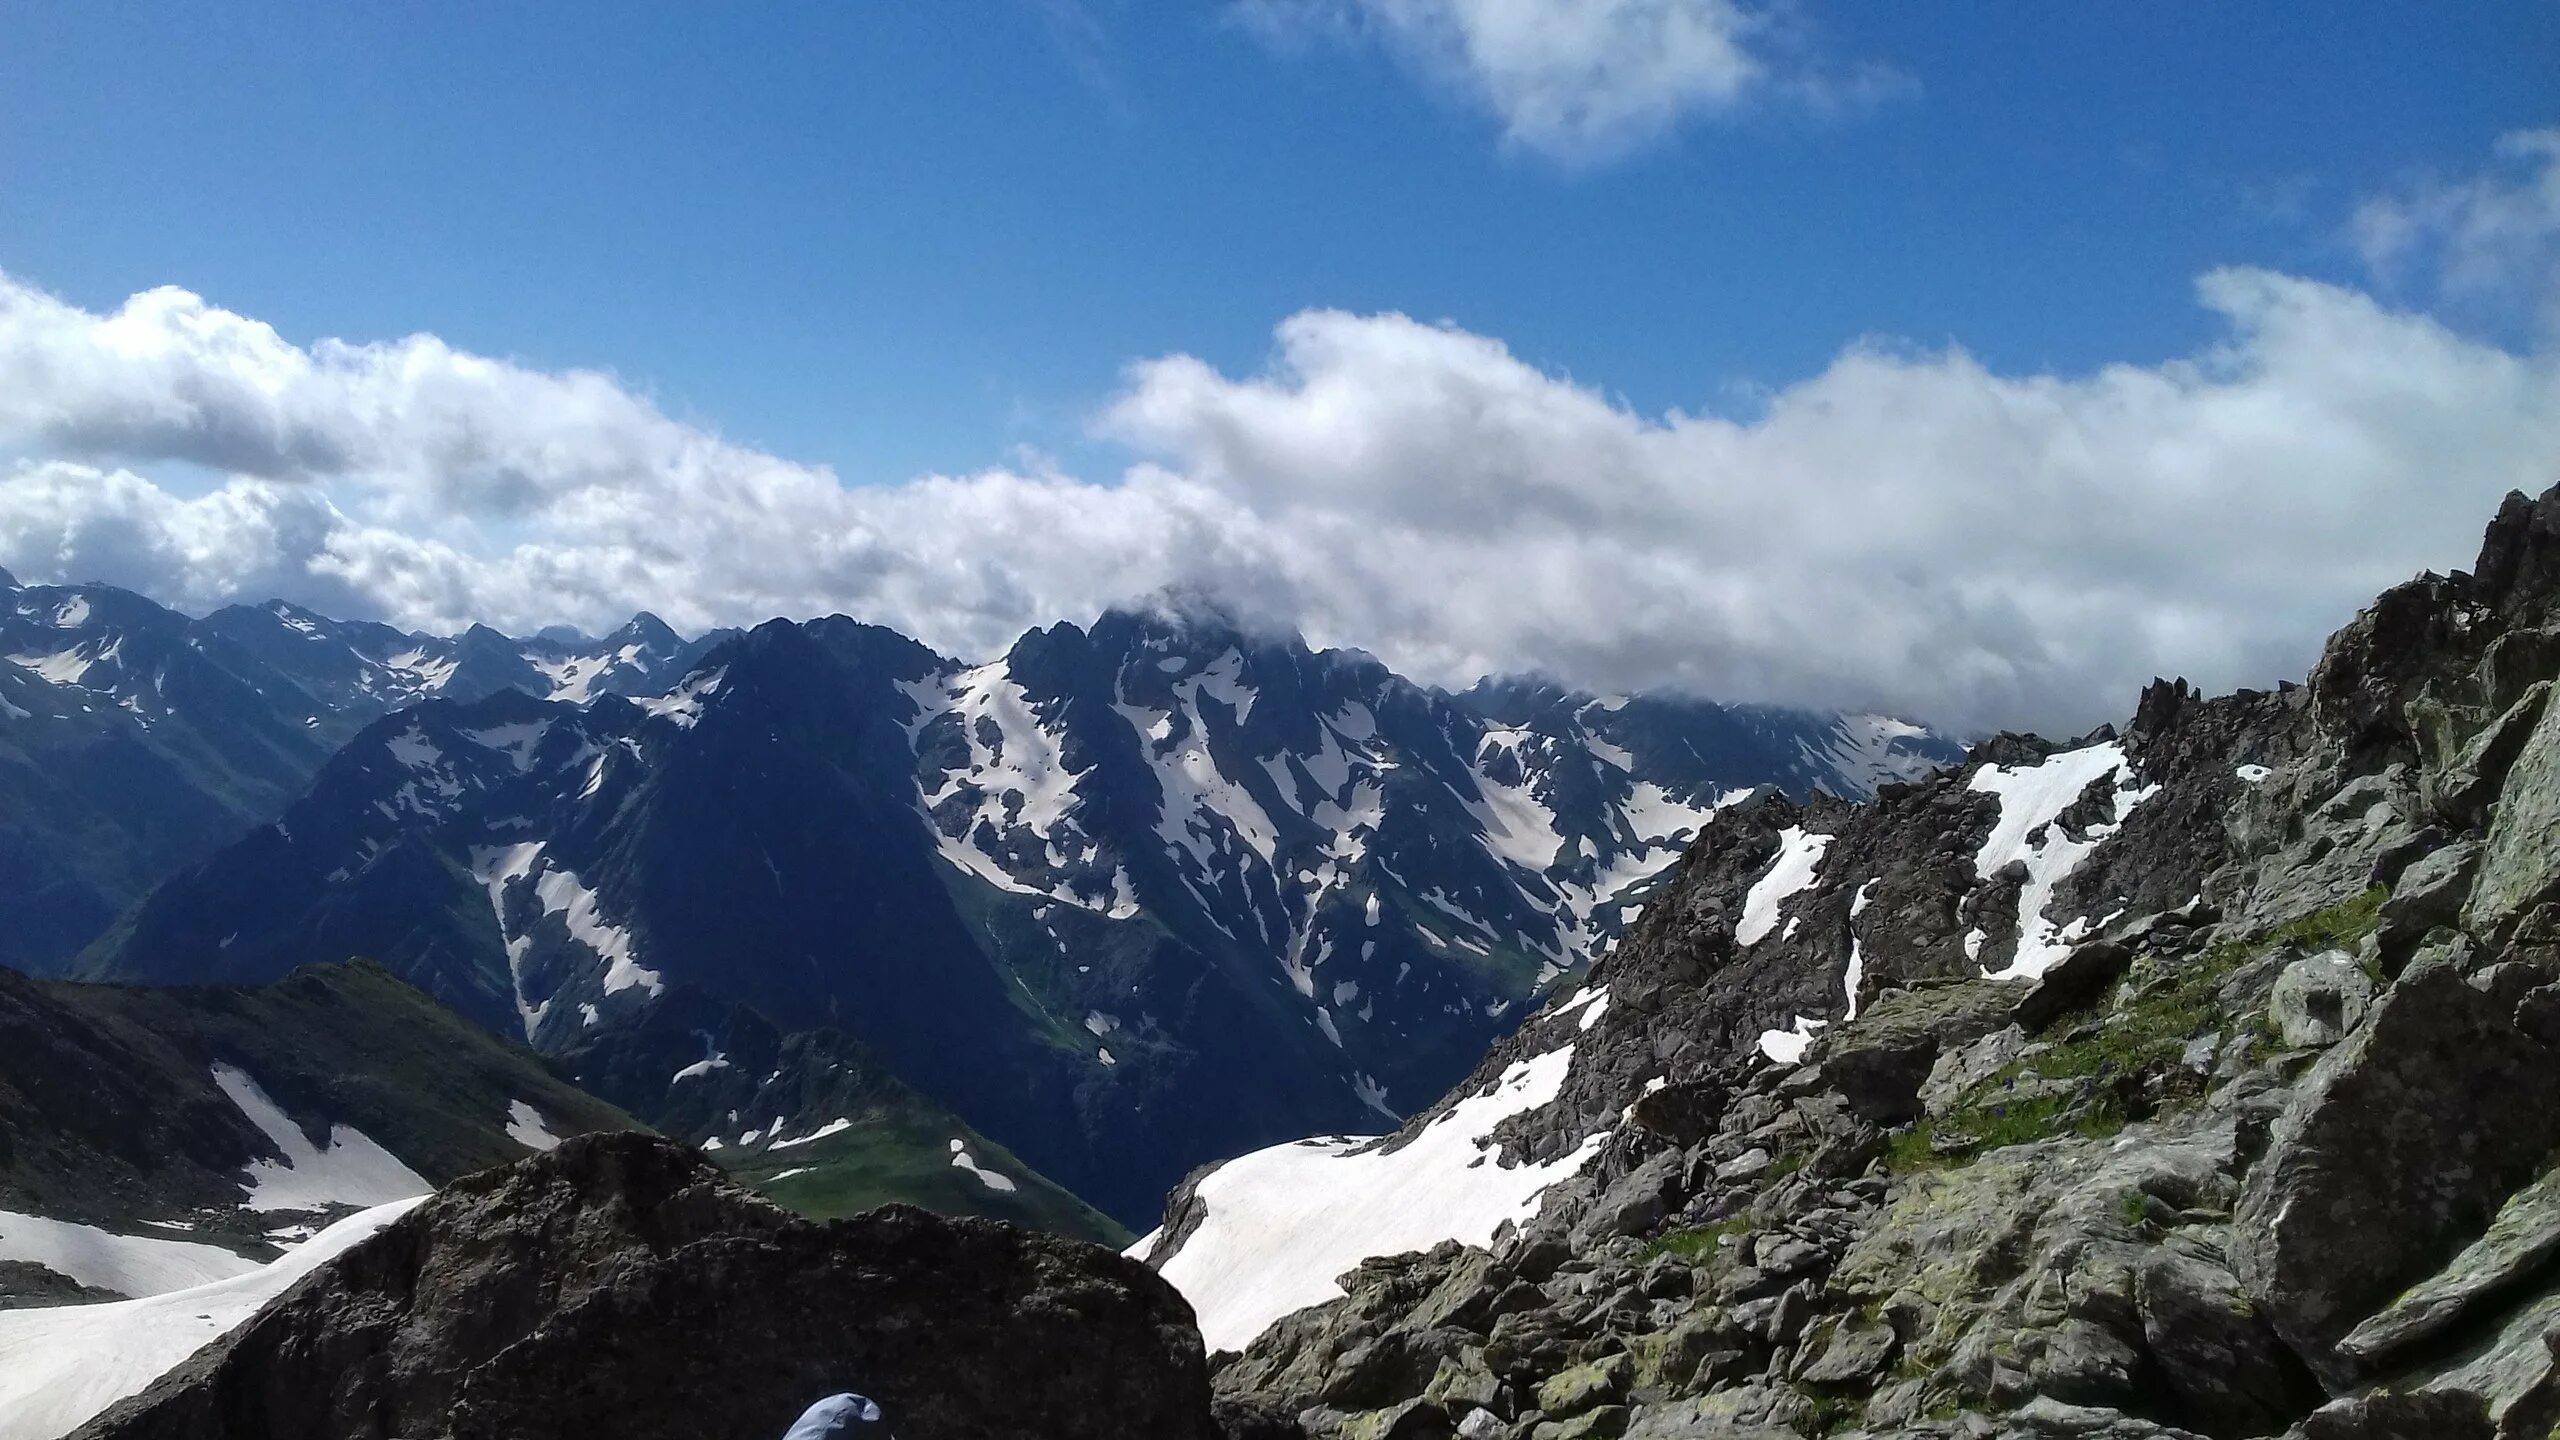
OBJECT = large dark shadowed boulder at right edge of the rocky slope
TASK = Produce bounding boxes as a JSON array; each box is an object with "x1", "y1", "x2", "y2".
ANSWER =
[{"x1": 2232, "y1": 956, "x2": 2560, "y2": 1386}]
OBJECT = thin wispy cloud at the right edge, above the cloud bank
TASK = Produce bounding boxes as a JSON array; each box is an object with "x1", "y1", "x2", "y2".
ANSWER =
[{"x1": 2348, "y1": 128, "x2": 2560, "y2": 333}]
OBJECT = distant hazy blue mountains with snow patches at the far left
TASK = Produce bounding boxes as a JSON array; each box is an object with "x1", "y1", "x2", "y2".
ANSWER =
[{"x1": 0, "y1": 574, "x2": 722, "y2": 974}]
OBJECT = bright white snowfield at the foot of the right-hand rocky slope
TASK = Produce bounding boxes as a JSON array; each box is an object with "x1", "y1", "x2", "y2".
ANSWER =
[{"x1": 1129, "y1": 1030, "x2": 1608, "y2": 1350}]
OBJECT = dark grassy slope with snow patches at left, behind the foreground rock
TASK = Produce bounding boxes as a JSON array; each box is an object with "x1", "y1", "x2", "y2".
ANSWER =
[{"x1": 0, "y1": 963, "x2": 632, "y2": 1294}]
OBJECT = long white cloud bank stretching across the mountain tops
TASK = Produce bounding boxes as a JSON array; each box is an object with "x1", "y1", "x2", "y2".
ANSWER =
[{"x1": 0, "y1": 269, "x2": 2560, "y2": 730}]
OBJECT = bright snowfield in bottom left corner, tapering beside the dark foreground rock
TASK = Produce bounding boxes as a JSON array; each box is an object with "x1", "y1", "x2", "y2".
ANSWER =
[{"x1": 0, "y1": 1197, "x2": 422, "y2": 1440}]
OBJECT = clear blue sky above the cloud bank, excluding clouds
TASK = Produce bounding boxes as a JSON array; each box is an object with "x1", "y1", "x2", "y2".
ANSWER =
[{"x1": 0, "y1": 0, "x2": 2560, "y2": 482}]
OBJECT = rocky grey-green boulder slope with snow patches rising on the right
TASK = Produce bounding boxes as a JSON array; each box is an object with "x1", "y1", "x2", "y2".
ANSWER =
[{"x1": 1155, "y1": 492, "x2": 2560, "y2": 1440}]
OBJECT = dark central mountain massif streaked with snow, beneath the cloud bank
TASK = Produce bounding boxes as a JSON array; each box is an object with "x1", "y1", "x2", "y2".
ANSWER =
[{"x1": 82, "y1": 604, "x2": 1951, "y2": 1220}]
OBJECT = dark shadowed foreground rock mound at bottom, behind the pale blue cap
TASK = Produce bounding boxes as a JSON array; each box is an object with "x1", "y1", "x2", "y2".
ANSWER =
[{"x1": 79, "y1": 1135, "x2": 1219, "y2": 1440}]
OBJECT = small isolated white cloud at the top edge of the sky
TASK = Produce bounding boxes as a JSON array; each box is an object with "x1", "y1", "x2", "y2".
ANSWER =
[{"x1": 1236, "y1": 0, "x2": 1900, "y2": 164}]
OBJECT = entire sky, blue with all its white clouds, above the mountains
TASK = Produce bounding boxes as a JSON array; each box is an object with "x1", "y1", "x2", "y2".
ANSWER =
[{"x1": 0, "y1": 0, "x2": 2560, "y2": 728}]
